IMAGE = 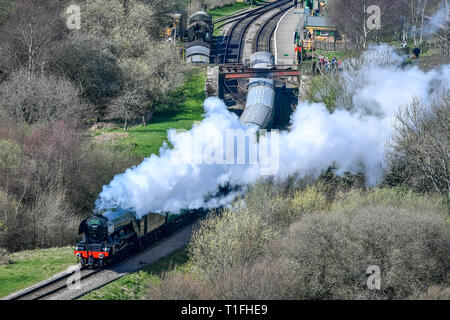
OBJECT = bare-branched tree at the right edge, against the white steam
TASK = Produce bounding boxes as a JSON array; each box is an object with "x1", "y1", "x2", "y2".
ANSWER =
[{"x1": 388, "y1": 93, "x2": 450, "y2": 197}]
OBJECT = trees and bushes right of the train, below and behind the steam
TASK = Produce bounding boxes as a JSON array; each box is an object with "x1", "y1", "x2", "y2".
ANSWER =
[{"x1": 145, "y1": 55, "x2": 450, "y2": 300}]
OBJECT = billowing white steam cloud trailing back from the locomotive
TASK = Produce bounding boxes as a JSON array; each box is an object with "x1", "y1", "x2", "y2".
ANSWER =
[{"x1": 96, "y1": 46, "x2": 450, "y2": 216}]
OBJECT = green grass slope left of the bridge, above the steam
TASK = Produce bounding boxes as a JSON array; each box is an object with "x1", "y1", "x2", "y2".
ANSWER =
[{"x1": 95, "y1": 70, "x2": 206, "y2": 157}]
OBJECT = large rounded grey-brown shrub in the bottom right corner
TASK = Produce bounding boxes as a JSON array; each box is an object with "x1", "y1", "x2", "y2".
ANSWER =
[{"x1": 284, "y1": 205, "x2": 450, "y2": 299}]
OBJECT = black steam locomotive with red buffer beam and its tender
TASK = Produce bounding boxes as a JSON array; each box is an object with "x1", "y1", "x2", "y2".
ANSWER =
[{"x1": 75, "y1": 208, "x2": 206, "y2": 267}]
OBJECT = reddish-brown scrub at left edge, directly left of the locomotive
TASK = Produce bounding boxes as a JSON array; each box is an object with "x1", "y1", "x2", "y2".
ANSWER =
[{"x1": 0, "y1": 121, "x2": 139, "y2": 252}]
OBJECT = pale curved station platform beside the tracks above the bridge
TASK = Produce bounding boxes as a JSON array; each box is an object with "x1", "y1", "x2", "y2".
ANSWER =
[{"x1": 274, "y1": 5, "x2": 305, "y2": 65}]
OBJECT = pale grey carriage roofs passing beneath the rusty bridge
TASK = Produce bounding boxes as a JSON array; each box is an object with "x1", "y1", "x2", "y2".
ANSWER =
[{"x1": 240, "y1": 52, "x2": 275, "y2": 129}]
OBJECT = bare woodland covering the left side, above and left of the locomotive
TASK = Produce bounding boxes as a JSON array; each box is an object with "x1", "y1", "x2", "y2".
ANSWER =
[{"x1": 0, "y1": 0, "x2": 195, "y2": 251}]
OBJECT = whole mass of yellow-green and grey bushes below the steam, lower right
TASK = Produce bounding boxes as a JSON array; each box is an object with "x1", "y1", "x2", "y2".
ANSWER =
[{"x1": 148, "y1": 182, "x2": 450, "y2": 300}]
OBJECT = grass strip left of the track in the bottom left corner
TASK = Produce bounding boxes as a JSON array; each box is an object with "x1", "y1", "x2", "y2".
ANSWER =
[{"x1": 0, "y1": 247, "x2": 77, "y2": 297}]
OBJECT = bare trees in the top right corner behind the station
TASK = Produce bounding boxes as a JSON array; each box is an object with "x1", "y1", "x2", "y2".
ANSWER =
[{"x1": 327, "y1": 0, "x2": 449, "y2": 51}]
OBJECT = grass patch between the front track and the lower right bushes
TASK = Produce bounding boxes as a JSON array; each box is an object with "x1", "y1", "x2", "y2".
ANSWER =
[{"x1": 81, "y1": 249, "x2": 189, "y2": 300}]
